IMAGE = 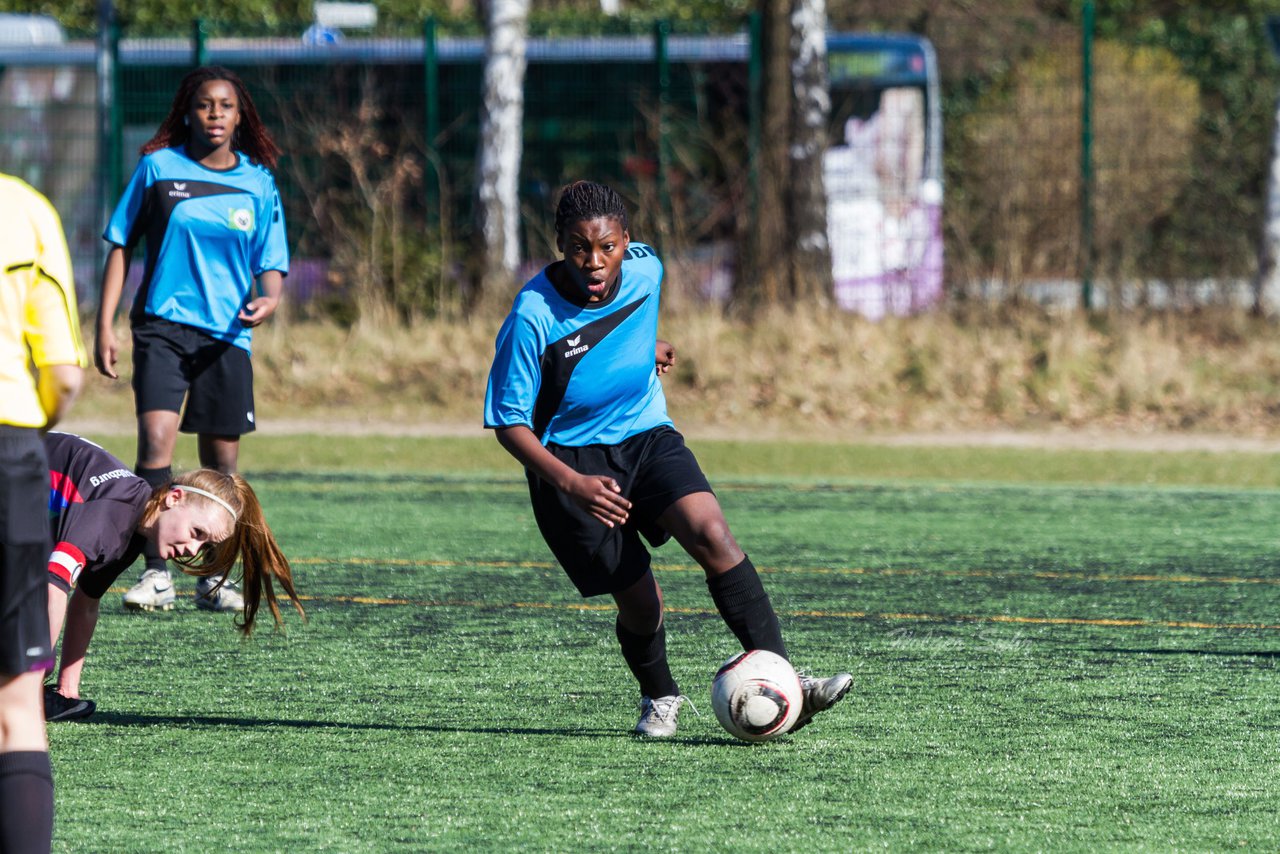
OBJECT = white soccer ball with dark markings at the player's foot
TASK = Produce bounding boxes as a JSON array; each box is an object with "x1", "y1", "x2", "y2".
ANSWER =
[{"x1": 712, "y1": 649, "x2": 804, "y2": 741}]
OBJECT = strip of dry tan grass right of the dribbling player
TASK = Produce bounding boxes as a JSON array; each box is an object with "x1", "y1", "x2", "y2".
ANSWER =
[{"x1": 667, "y1": 311, "x2": 1280, "y2": 434}]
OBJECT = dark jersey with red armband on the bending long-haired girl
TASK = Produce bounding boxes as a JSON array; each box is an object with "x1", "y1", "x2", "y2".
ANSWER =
[{"x1": 45, "y1": 433, "x2": 151, "y2": 590}]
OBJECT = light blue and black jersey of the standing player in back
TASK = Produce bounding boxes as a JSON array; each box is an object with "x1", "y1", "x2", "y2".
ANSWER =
[{"x1": 102, "y1": 147, "x2": 289, "y2": 350}]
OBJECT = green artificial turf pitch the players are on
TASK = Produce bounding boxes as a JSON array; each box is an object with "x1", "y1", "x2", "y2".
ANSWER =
[{"x1": 50, "y1": 437, "x2": 1280, "y2": 851}]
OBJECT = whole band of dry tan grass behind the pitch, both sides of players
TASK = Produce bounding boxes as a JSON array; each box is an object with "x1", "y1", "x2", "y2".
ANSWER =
[{"x1": 67, "y1": 309, "x2": 1280, "y2": 437}]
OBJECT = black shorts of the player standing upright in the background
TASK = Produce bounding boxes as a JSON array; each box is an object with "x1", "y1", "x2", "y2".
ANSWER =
[{"x1": 133, "y1": 318, "x2": 255, "y2": 435}]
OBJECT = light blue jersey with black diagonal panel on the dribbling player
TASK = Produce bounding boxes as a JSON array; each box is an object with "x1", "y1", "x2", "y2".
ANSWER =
[{"x1": 484, "y1": 236, "x2": 671, "y2": 447}]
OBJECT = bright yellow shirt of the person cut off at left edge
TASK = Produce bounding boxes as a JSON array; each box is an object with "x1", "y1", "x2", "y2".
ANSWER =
[{"x1": 0, "y1": 174, "x2": 88, "y2": 428}]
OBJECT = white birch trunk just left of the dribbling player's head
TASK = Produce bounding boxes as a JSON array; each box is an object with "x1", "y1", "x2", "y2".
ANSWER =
[{"x1": 472, "y1": 0, "x2": 530, "y2": 300}]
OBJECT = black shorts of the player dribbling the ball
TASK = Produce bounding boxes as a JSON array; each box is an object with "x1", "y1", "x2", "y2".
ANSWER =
[{"x1": 529, "y1": 426, "x2": 712, "y2": 597}]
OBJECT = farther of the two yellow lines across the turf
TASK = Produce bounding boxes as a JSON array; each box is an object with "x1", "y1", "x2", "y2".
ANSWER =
[{"x1": 291, "y1": 557, "x2": 1280, "y2": 585}]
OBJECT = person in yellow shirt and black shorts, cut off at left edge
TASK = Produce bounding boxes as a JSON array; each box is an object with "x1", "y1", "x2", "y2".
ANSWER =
[{"x1": 0, "y1": 174, "x2": 88, "y2": 851}]
